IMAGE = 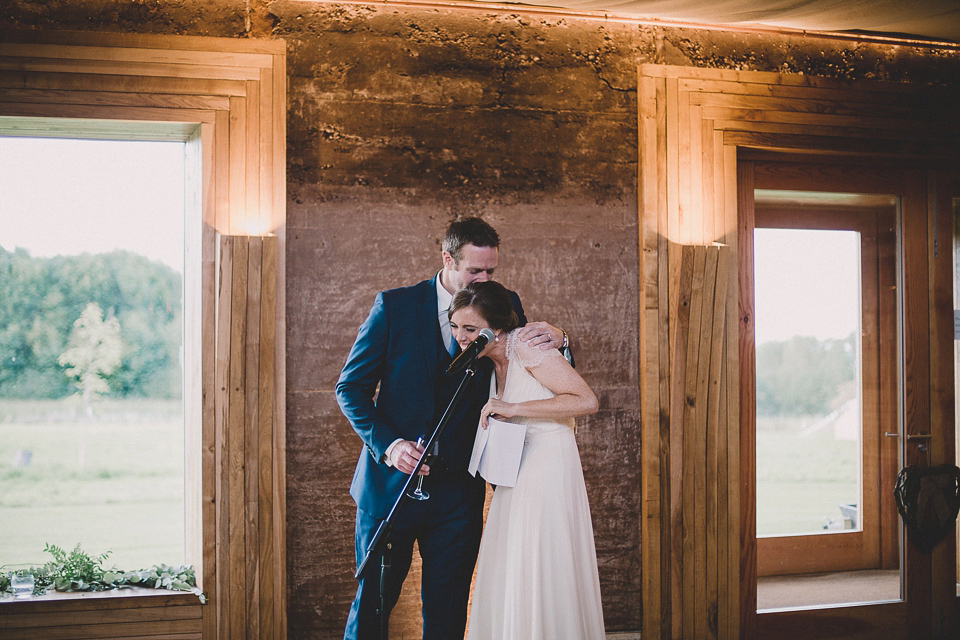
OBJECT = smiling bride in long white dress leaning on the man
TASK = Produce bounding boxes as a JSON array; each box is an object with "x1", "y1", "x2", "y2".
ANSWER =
[{"x1": 449, "y1": 281, "x2": 604, "y2": 640}]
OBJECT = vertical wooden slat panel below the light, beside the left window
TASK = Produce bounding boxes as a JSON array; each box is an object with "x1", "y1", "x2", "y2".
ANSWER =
[{"x1": 215, "y1": 236, "x2": 282, "y2": 638}]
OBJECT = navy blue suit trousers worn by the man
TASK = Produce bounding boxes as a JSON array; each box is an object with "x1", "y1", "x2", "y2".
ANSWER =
[{"x1": 344, "y1": 471, "x2": 484, "y2": 640}]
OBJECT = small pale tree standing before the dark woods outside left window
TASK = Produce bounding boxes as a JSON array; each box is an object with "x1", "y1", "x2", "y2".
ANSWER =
[{"x1": 59, "y1": 302, "x2": 123, "y2": 415}]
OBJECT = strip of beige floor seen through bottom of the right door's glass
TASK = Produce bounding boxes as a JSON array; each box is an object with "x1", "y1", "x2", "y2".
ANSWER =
[{"x1": 757, "y1": 569, "x2": 900, "y2": 610}]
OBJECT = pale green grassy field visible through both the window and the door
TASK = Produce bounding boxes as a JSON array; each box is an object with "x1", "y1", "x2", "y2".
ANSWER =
[{"x1": 0, "y1": 400, "x2": 859, "y2": 569}]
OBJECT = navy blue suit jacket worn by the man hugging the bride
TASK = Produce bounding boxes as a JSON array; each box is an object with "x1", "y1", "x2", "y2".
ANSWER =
[{"x1": 336, "y1": 276, "x2": 526, "y2": 518}]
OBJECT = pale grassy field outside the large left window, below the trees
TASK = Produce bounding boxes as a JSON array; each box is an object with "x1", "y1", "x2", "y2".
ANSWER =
[{"x1": 0, "y1": 400, "x2": 184, "y2": 569}]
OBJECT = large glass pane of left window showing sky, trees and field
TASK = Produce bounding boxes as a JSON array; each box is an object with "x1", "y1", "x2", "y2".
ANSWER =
[{"x1": 0, "y1": 138, "x2": 185, "y2": 570}]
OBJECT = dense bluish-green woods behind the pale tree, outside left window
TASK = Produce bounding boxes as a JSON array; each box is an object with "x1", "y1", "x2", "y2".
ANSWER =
[{"x1": 0, "y1": 248, "x2": 182, "y2": 398}]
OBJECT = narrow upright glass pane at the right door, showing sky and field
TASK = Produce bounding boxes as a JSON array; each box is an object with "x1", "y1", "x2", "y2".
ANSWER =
[{"x1": 755, "y1": 229, "x2": 863, "y2": 537}]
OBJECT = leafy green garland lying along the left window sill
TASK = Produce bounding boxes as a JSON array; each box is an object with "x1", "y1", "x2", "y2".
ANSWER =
[{"x1": 0, "y1": 544, "x2": 206, "y2": 602}]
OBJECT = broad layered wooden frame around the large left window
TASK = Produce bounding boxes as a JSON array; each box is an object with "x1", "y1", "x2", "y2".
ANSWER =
[{"x1": 0, "y1": 30, "x2": 286, "y2": 638}]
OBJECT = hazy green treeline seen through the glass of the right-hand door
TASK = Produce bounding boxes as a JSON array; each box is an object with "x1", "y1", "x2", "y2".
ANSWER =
[{"x1": 757, "y1": 334, "x2": 859, "y2": 416}]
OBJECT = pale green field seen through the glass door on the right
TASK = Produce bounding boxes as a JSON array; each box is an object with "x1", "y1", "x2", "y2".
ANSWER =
[{"x1": 757, "y1": 430, "x2": 860, "y2": 536}]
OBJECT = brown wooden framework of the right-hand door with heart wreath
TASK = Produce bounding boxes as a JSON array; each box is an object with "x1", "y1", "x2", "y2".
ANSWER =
[{"x1": 739, "y1": 152, "x2": 942, "y2": 640}]
